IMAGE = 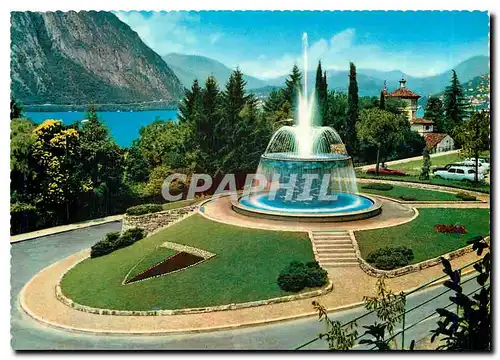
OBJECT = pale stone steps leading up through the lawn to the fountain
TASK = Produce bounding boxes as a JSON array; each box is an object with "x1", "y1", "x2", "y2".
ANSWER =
[{"x1": 311, "y1": 231, "x2": 359, "y2": 267}]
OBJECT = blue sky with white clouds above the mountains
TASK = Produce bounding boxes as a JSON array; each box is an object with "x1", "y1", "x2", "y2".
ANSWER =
[{"x1": 116, "y1": 11, "x2": 489, "y2": 78}]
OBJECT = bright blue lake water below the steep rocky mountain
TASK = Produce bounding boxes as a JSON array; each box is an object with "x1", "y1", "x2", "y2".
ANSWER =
[{"x1": 26, "y1": 110, "x2": 177, "y2": 147}]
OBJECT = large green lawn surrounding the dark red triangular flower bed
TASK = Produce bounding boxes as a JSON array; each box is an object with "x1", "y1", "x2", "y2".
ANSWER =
[{"x1": 62, "y1": 214, "x2": 314, "y2": 310}]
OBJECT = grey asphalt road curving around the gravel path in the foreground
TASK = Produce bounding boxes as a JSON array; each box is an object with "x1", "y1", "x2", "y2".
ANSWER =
[{"x1": 11, "y1": 222, "x2": 476, "y2": 350}]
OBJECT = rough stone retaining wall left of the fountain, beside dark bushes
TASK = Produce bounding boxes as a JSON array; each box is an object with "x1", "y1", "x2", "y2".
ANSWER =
[{"x1": 122, "y1": 205, "x2": 198, "y2": 235}]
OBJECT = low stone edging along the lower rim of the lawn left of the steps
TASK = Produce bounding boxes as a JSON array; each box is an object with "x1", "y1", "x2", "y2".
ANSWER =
[{"x1": 56, "y1": 280, "x2": 333, "y2": 316}]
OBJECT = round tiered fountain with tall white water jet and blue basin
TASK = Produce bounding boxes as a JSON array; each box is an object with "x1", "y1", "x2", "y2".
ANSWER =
[{"x1": 232, "y1": 33, "x2": 381, "y2": 221}]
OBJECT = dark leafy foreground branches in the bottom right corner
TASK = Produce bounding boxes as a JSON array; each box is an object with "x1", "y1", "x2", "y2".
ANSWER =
[{"x1": 431, "y1": 236, "x2": 492, "y2": 351}]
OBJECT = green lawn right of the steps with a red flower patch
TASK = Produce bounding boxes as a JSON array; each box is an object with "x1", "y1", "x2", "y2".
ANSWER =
[{"x1": 355, "y1": 208, "x2": 490, "y2": 263}]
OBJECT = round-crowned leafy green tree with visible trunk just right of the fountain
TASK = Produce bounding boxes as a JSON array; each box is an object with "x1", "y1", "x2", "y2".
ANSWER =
[{"x1": 356, "y1": 108, "x2": 407, "y2": 175}]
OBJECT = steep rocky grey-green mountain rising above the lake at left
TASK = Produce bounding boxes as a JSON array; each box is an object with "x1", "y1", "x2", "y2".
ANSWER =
[{"x1": 11, "y1": 11, "x2": 184, "y2": 104}]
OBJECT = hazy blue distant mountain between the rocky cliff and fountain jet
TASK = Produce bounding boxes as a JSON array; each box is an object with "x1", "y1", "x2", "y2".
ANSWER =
[{"x1": 163, "y1": 53, "x2": 267, "y2": 89}]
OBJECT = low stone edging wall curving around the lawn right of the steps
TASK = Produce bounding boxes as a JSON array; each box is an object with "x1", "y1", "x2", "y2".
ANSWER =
[{"x1": 349, "y1": 231, "x2": 480, "y2": 278}]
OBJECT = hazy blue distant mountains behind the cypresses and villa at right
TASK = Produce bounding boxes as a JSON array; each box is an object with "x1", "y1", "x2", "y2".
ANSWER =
[{"x1": 268, "y1": 56, "x2": 490, "y2": 96}]
